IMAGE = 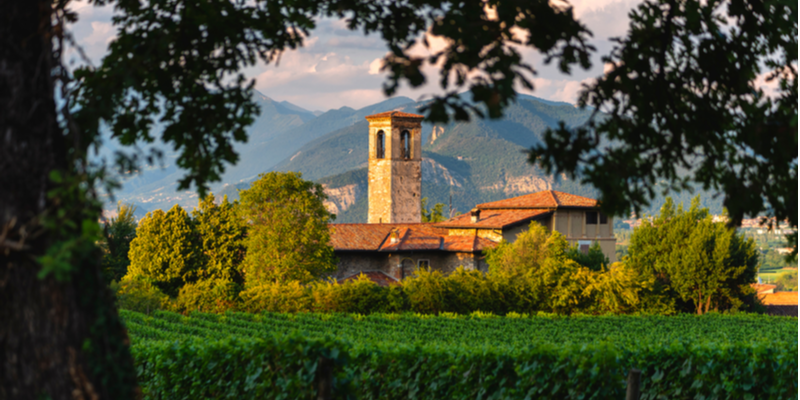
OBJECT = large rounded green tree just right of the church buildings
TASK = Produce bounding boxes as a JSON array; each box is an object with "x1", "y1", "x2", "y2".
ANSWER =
[{"x1": 623, "y1": 198, "x2": 758, "y2": 314}]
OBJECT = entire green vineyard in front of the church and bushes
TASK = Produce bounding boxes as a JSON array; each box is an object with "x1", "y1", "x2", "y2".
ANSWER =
[{"x1": 121, "y1": 310, "x2": 798, "y2": 399}]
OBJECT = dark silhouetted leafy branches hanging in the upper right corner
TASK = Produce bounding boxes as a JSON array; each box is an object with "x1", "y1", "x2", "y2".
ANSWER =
[{"x1": 530, "y1": 0, "x2": 798, "y2": 249}]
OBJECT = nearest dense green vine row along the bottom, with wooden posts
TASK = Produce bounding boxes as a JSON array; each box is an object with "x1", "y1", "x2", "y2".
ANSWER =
[{"x1": 133, "y1": 334, "x2": 798, "y2": 400}]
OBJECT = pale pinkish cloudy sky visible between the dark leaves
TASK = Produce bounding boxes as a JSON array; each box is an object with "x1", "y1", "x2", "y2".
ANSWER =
[{"x1": 67, "y1": 0, "x2": 640, "y2": 111}]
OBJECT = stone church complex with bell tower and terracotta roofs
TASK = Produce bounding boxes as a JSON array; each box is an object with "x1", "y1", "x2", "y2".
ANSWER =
[{"x1": 330, "y1": 111, "x2": 616, "y2": 285}]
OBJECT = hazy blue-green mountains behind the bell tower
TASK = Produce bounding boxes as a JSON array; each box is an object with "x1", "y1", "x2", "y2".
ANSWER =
[{"x1": 101, "y1": 88, "x2": 716, "y2": 222}]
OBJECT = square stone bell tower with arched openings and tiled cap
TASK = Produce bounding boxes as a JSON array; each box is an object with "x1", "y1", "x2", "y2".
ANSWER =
[{"x1": 367, "y1": 111, "x2": 424, "y2": 224}]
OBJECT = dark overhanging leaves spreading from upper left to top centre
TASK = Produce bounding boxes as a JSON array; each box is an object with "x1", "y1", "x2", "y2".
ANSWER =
[{"x1": 75, "y1": 0, "x2": 591, "y2": 196}]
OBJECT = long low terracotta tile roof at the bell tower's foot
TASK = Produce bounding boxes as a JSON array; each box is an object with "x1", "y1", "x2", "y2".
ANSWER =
[{"x1": 330, "y1": 223, "x2": 495, "y2": 252}]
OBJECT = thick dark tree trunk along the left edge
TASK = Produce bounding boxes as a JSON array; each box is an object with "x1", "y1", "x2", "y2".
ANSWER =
[{"x1": 0, "y1": 0, "x2": 136, "y2": 400}]
